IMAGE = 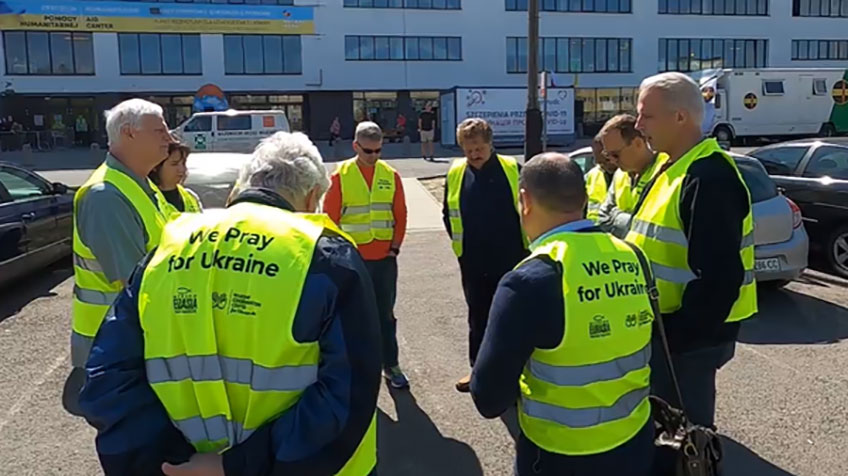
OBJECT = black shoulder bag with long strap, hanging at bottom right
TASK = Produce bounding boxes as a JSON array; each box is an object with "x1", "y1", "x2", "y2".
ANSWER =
[{"x1": 627, "y1": 243, "x2": 724, "y2": 476}]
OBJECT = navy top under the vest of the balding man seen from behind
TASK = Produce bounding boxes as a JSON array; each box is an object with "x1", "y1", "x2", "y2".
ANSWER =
[{"x1": 471, "y1": 220, "x2": 653, "y2": 475}]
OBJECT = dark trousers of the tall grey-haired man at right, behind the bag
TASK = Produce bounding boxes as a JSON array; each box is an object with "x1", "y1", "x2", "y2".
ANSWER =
[{"x1": 651, "y1": 339, "x2": 736, "y2": 475}]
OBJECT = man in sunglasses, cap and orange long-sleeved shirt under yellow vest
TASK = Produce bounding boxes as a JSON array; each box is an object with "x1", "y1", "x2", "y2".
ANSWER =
[{"x1": 324, "y1": 121, "x2": 409, "y2": 388}]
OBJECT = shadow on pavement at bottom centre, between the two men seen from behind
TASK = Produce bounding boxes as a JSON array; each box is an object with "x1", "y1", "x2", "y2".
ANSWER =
[{"x1": 377, "y1": 388, "x2": 483, "y2": 476}]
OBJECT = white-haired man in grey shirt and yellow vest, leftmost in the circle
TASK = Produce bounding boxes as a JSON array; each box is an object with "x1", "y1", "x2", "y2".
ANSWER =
[{"x1": 66, "y1": 99, "x2": 171, "y2": 380}]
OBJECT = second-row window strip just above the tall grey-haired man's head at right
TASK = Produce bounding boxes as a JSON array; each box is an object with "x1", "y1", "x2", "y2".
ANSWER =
[{"x1": 658, "y1": 38, "x2": 768, "y2": 72}]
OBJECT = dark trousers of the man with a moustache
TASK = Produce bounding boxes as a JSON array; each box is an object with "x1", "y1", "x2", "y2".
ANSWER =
[{"x1": 460, "y1": 266, "x2": 506, "y2": 367}]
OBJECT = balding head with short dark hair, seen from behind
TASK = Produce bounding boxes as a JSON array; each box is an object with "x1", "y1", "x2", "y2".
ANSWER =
[{"x1": 519, "y1": 152, "x2": 586, "y2": 213}]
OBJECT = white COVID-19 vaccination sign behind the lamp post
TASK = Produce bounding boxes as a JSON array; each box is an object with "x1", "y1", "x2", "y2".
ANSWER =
[{"x1": 456, "y1": 88, "x2": 574, "y2": 136}]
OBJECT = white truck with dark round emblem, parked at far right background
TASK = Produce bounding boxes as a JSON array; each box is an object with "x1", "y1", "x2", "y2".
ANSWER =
[{"x1": 691, "y1": 68, "x2": 848, "y2": 143}]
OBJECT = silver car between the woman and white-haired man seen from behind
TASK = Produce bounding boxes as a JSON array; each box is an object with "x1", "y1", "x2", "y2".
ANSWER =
[{"x1": 185, "y1": 152, "x2": 253, "y2": 208}]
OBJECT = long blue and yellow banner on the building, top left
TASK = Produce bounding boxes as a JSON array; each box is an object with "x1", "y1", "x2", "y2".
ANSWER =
[{"x1": 0, "y1": 0, "x2": 315, "y2": 35}]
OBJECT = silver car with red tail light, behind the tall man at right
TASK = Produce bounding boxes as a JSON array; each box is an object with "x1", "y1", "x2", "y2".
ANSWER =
[{"x1": 570, "y1": 147, "x2": 809, "y2": 286}]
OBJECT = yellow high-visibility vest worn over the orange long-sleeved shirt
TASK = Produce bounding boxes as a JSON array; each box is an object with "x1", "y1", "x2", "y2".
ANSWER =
[{"x1": 338, "y1": 158, "x2": 397, "y2": 245}]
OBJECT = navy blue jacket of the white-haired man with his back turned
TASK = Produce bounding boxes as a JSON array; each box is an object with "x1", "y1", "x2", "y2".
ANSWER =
[{"x1": 80, "y1": 189, "x2": 381, "y2": 476}]
